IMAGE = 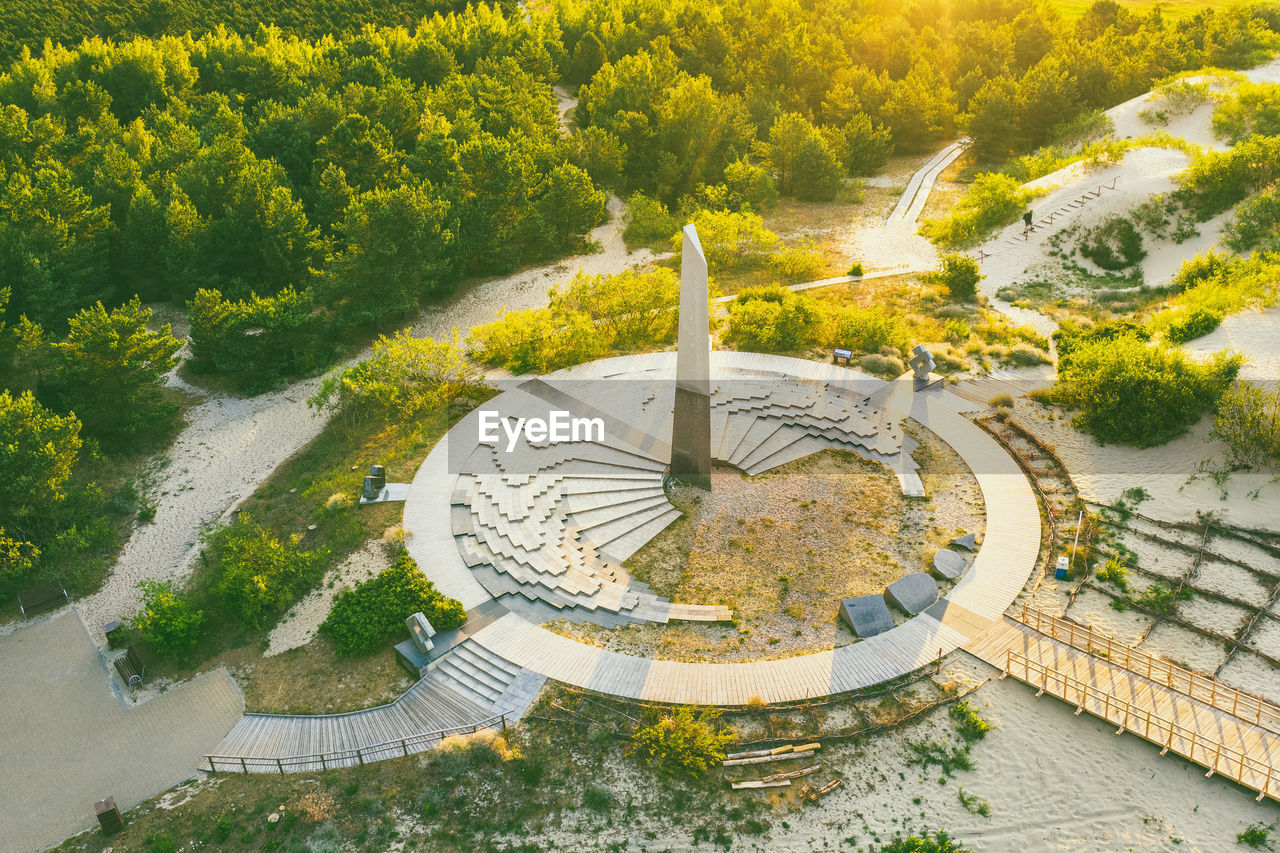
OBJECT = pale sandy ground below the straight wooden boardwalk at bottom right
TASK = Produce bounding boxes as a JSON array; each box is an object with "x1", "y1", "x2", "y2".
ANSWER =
[{"x1": 481, "y1": 654, "x2": 1280, "y2": 853}]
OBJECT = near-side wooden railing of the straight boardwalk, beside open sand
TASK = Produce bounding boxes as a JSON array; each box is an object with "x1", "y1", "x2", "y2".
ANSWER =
[{"x1": 1001, "y1": 651, "x2": 1280, "y2": 802}]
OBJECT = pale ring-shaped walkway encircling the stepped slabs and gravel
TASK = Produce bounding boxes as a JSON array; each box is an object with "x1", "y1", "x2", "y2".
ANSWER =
[{"x1": 404, "y1": 352, "x2": 1041, "y2": 704}]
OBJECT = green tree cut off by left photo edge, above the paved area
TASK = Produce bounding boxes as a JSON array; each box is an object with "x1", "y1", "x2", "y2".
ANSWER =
[{"x1": 0, "y1": 389, "x2": 81, "y2": 530}]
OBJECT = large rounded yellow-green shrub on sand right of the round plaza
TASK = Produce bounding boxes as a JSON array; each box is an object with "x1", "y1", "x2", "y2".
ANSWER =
[{"x1": 1052, "y1": 329, "x2": 1240, "y2": 447}]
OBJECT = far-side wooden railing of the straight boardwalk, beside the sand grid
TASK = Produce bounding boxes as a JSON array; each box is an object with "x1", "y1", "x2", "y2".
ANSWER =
[{"x1": 1016, "y1": 605, "x2": 1280, "y2": 733}]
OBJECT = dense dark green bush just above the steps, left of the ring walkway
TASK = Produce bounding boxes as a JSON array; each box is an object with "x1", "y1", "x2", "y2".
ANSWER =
[{"x1": 320, "y1": 551, "x2": 467, "y2": 657}]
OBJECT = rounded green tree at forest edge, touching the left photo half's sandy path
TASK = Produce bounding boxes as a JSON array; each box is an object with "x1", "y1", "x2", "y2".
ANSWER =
[{"x1": 42, "y1": 297, "x2": 182, "y2": 439}]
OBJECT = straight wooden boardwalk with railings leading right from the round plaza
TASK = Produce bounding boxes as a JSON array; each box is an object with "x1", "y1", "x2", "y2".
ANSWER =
[{"x1": 965, "y1": 610, "x2": 1280, "y2": 800}]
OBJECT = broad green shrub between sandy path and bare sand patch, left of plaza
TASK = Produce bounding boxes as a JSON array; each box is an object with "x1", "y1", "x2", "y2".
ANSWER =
[{"x1": 205, "y1": 512, "x2": 329, "y2": 629}]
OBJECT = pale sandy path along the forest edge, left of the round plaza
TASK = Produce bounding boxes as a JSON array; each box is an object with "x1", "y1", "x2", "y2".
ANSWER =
[{"x1": 64, "y1": 199, "x2": 653, "y2": 630}]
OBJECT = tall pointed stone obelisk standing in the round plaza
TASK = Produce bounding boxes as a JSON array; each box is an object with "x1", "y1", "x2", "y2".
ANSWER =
[{"x1": 671, "y1": 225, "x2": 712, "y2": 491}]
